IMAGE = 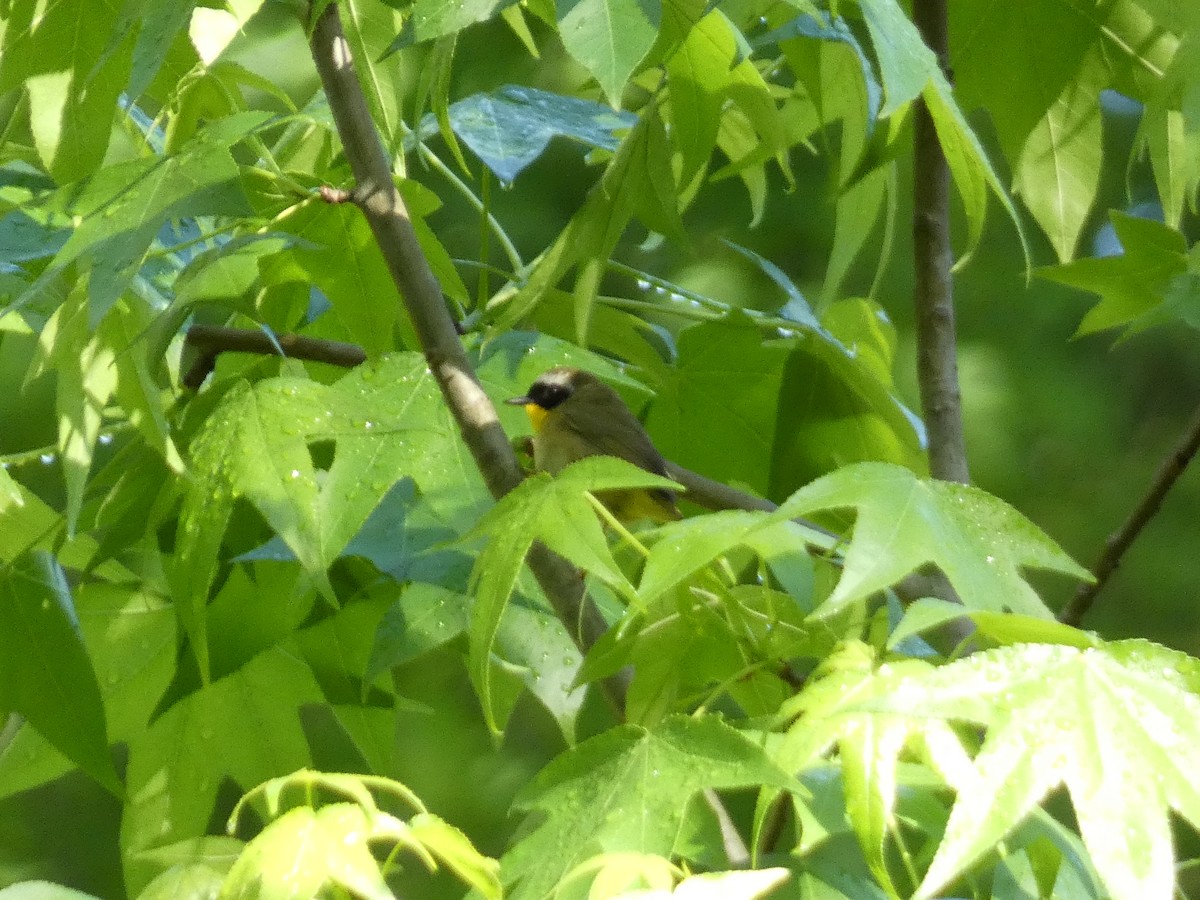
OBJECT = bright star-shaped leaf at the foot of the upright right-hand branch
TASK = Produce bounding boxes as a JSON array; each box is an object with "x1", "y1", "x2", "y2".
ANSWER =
[{"x1": 778, "y1": 463, "x2": 1090, "y2": 618}]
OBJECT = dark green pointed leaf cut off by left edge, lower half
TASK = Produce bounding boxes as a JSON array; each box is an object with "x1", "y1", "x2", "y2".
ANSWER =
[{"x1": 0, "y1": 551, "x2": 122, "y2": 794}]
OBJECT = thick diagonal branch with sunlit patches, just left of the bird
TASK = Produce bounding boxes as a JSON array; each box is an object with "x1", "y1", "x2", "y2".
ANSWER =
[{"x1": 310, "y1": 4, "x2": 628, "y2": 713}]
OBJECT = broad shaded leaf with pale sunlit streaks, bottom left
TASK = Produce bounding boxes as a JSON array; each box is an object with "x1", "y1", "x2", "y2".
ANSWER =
[{"x1": 121, "y1": 647, "x2": 324, "y2": 895}]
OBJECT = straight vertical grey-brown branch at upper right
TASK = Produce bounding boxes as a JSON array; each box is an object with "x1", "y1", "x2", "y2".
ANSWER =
[{"x1": 912, "y1": 0, "x2": 971, "y2": 484}]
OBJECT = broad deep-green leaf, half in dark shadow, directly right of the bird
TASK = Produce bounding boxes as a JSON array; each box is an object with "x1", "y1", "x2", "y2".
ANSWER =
[{"x1": 646, "y1": 313, "x2": 923, "y2": 497}]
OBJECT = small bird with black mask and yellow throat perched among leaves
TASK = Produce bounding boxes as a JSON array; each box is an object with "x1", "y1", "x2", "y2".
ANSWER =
[{"x1": 508, "y1": 366, "x2": 680, "y2": 522}]
